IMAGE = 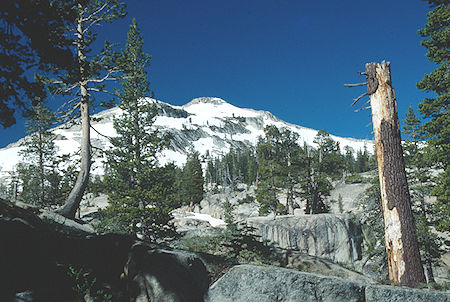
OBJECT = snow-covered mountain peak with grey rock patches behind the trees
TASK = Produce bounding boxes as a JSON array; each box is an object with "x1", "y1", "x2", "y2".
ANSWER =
[{"x1": 0, "y1": 97, "x2": 373, "y2": 175}]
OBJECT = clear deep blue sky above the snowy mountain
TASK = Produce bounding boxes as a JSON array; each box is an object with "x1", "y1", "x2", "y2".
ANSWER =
[{"x1": 0, "y1": 0, "x2": 435, "y2": 147}]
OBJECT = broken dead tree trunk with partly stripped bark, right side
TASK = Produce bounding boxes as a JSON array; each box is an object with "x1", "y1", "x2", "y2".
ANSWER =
[{"x1": 366, "y1": 62, "x2": 425, "y2": 286}]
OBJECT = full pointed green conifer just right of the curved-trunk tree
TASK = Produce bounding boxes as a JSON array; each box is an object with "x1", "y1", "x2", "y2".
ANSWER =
[{"x1": 104, "y1": 20, "x2": 175, "y2": 239}]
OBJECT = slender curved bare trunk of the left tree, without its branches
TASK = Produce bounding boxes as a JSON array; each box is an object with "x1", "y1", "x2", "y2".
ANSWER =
[{"x1": 57, "y1": 5, "x2": 91, "y2": 218}]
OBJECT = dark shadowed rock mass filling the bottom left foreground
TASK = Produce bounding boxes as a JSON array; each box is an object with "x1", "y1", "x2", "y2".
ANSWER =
[{"x1": 0, "y1": 199, "x2": 209, "y2": 302}]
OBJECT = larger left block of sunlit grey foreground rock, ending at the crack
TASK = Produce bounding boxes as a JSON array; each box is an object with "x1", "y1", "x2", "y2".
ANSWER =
[{"x1": 205, "y1": 265, "x2": 364, "y2": 302}]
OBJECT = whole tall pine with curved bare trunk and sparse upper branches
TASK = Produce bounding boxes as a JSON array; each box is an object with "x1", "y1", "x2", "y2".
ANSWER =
[{"x1": 49, "y1": 0, "x2": 125, "y2": 218}]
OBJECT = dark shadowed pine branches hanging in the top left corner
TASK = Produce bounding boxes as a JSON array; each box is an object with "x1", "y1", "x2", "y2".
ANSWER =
[{"x1": 0, "y1": 0, "x2": 76, "y2": 127}]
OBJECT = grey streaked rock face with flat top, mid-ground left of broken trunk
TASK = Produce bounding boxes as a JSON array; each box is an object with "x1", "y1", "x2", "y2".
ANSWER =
[{"x1": 247, "y1": 214, "x2": 362, "y2": 263}]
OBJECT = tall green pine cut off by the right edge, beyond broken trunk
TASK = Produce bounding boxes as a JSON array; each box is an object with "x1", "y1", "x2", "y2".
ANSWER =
[{"x1": 417, "y1": 0, "x2": 450, "y2": 232}]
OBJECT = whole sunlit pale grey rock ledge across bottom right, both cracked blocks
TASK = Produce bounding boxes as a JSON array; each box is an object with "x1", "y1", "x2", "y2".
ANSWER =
[{"x1": 205, "y1": 265, "x2": 450, "y2": 302}]
